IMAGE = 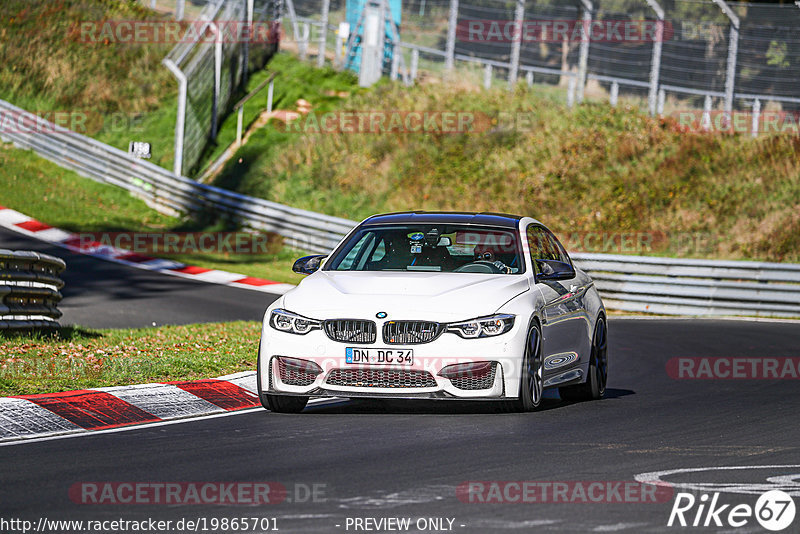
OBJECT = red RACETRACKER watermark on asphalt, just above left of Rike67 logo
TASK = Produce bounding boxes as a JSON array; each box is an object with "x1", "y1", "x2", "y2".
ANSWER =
[{"x1": 456, "y1": 480, "x2": 674, "y2": 504}]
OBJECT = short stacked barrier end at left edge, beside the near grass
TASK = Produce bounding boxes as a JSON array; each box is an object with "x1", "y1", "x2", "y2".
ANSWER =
[{"x1": 0, "y1": 249, "x2": 67, "y2": 330}]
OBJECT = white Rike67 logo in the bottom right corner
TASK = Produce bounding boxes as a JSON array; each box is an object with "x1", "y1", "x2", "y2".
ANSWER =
[{"x1": 667, "y1": 490, "x2": 796, "y2": 532}]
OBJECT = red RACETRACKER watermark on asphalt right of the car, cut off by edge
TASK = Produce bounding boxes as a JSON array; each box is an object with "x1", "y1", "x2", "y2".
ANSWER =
[{"x1": 666, "y1": 356, "x2": 800, "y2": 380}]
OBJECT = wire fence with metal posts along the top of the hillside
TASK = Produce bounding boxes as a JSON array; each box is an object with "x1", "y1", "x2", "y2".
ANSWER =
[{"x1": 284, "y1": 0, "x2": 800, "y2": 117}]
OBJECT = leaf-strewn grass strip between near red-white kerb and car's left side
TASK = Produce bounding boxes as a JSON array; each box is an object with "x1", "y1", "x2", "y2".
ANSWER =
[{"x1": 0, "y1": 322, "x2": 261, "y2": 395}]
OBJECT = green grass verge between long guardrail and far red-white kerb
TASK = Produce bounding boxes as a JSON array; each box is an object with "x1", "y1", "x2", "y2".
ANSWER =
[{"x1": 0, "y1": 144, "x2": 304, "y2": 283}]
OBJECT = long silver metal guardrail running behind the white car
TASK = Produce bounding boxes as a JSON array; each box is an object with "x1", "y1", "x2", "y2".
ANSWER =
[{"x1": 0, "y1": 100, "x2": 800, "y2": 317}]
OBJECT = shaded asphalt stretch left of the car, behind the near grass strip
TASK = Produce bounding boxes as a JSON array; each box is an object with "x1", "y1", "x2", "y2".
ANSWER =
[{"x1": 0, "y1": 228, "x2": 277, "y2": 328}]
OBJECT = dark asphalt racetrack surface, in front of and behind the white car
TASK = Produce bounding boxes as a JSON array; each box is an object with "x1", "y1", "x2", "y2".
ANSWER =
[{"x1": 0, "y1": 226, "x2": 800, "y2": 533}]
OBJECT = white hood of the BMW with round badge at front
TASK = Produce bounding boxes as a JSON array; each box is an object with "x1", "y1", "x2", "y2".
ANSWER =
[{"x1": 283, "y1": 271, "x2": 530, "y2": 321}]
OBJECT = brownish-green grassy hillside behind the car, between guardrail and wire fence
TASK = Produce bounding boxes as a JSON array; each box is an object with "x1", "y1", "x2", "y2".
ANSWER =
[{"x1": 209, "y1": 61, "x2": 800, "y2": 262}]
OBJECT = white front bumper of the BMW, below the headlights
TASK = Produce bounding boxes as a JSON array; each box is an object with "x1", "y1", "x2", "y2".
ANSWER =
[{"x1": 259, "y1": 324, "x2": 525, "y2": 400}]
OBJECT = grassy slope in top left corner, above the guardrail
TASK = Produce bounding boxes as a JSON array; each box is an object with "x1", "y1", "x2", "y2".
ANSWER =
[{"x1": 0, "y1": 0, "x2": 177, "y2": 168}]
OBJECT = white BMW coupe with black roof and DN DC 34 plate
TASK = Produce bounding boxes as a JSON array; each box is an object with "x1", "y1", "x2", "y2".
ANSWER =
[{"x1": 258, "y1": 212, "x2": 608, "y2": 412}]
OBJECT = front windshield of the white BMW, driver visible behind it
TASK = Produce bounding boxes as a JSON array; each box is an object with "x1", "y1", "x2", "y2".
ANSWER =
[{"x1": 324, "y1": 224, "x2": 525, "y2": 274}]
